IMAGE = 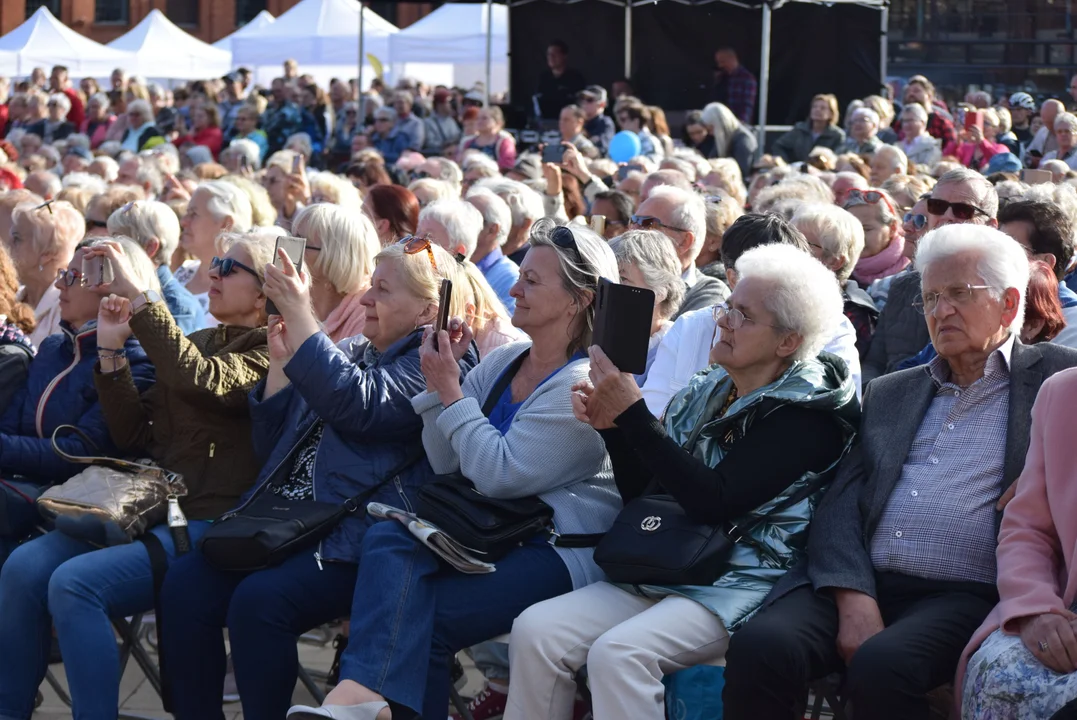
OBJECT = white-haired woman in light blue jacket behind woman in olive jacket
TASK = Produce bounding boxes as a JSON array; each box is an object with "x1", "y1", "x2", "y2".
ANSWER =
[{"x1": 108, "y1": 200, "x2": 206, "y2": 335}]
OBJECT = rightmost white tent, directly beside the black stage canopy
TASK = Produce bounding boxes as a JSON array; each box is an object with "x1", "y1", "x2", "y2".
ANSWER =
[{"x1": 389, "y1": 3, "x2": 508, "y2": 93}]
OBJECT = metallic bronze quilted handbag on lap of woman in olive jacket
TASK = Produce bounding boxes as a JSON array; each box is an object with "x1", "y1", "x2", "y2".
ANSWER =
[{"x1": 38, "y1": 425, "x2": 187, "y2": 543}]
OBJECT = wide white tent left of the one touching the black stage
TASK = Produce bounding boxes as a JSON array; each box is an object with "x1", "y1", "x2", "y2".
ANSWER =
[{"x1": 232, "y1": 0, "x2": 400, "y2": 84}]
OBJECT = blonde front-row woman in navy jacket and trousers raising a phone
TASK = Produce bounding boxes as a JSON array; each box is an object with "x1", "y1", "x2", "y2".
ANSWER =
[{"x1": 160, "y1": 238, "x2": 478, "y2": 720}]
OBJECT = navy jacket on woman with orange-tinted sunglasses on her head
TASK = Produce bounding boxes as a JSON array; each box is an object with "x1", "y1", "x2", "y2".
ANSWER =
[{"x1": 244, "y1": 330, "x2": 478, "y2": 563}]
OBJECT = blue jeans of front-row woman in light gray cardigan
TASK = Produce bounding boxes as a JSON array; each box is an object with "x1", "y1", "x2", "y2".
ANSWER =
[{"x1": 340, "y1": 521, "x2": 572, "y2": 718}]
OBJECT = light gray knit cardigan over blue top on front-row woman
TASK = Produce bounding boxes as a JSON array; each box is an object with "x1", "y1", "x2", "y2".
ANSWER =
[{"x1": 411, "y1": 340, "x2": 620, "y2": 588}]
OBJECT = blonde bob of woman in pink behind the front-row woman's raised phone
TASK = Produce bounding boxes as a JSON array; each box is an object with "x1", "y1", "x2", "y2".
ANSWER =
[{"x1": 292, "y1": 203, "x2": 381, "y2": 295}]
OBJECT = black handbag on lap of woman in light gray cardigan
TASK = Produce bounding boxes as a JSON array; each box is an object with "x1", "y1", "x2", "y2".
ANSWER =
[{"x1": 417, "y1": 351, "x2": 602, "y2": 562}]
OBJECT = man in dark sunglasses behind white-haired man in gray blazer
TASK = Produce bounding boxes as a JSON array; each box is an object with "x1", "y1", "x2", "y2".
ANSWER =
[{"x1": 864, "y1": 168, "x2": 998, "y2": 384}]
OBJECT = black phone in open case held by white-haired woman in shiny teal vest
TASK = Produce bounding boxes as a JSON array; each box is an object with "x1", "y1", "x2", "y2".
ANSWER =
[{"x1": 595, "y1": 278, "x2": 655, "y2": 375}]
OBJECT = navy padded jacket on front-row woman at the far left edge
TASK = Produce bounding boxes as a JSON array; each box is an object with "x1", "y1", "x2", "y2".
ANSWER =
[{"x1": 0, "y1": 322, "x2": 154, "y2": 485}]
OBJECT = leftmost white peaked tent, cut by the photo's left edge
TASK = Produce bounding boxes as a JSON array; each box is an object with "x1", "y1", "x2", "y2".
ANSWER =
[{"x1": 0, "y1": 6, "x2": 132, "y2": 77}]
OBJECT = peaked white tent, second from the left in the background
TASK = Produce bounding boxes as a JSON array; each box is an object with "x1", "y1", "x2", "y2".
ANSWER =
[{"x1": 108, "y1": 10, "x2": 232, "y2": 80}]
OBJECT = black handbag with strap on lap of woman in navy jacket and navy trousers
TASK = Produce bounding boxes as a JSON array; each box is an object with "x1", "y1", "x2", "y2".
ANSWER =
[{"x1": 198, "y1": 446, "x2": 424, "y2": 573}]
